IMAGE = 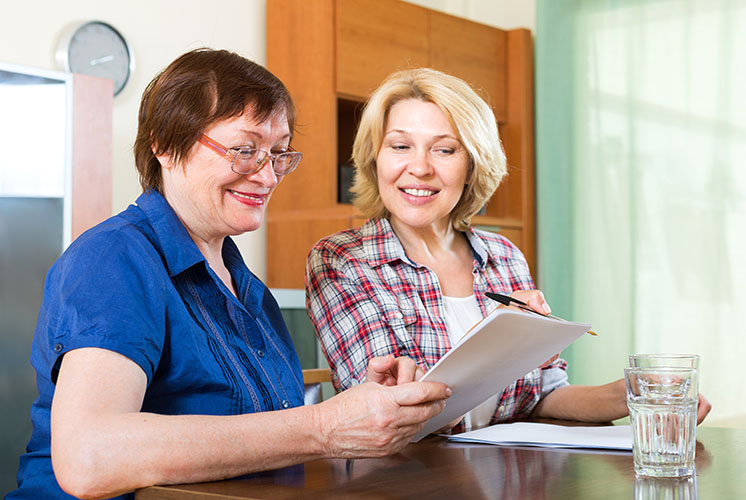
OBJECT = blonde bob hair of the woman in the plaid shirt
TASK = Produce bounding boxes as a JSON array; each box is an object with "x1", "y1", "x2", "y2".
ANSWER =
[{"x1": 351, "y1": 68, "x2": 506, "y2": 231}]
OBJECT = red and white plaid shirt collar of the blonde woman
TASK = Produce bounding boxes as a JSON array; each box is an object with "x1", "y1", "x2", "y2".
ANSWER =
[{"x1": 360, "y1": 218, "x2": 499, "y2": 268}]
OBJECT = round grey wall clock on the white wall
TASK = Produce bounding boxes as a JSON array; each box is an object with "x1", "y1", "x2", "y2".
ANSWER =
[{"x1": 58, "y1": 21, "x2": 133, "y2": 95}]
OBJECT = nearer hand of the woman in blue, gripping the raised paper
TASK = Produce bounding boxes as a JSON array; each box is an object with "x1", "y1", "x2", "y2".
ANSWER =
[{"x1": 315, "y1": 364, "x2": 451, "y2": 458}]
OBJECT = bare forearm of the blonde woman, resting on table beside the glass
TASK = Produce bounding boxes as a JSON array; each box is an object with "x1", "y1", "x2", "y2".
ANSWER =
[{"x1": 532, "y1": 379, "x2": 628, "y2": 422}]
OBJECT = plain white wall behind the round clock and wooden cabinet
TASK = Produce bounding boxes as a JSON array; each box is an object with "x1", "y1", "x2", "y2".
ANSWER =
[{"x1": 0, "y1": 0, "x2": 535, "y2": 278}]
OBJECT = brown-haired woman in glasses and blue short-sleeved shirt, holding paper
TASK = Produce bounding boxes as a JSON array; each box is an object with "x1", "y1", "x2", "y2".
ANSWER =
[{"x1": 8, "y1": 49, "x2": 449, "y2": 498}]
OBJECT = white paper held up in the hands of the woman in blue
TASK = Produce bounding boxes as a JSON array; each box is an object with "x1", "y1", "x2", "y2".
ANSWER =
[{"x1": 413, "y1": 308, "x2": 591, "y2": 441}]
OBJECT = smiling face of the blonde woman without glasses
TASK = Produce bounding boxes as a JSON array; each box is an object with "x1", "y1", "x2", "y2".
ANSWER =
[{"x1": 376, "y1": 99, "x2": 469, "y2": 236}]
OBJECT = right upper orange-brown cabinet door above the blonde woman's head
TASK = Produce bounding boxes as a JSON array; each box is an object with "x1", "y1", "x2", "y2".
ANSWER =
[{"x1": 429, "y1": 12, "x2": 507, "y2": 122}]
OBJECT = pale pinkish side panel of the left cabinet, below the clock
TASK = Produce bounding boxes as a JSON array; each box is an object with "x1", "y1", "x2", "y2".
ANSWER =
[{"x1": 71, "y1": 74, "x2": 114, "y2": 240}]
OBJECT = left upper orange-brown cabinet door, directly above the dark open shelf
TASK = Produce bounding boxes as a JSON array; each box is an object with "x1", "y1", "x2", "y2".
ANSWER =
[{"x1": 336, "y1": 0, "x2": 429, "y2": 98}]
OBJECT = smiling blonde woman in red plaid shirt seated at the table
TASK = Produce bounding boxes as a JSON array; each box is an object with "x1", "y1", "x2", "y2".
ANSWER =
[{"x1": 306, "y1": 68, "x2": 709, "y2": 434}]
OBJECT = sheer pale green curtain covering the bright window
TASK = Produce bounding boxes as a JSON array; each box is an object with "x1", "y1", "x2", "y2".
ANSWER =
[{"x1": 536, "y1": 0, "x2": 746, "y2": 426}]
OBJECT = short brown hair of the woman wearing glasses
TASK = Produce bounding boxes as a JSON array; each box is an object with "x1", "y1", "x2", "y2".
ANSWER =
[{"x1": 134, "y1": 48, "x2": 295, "y2": 191}]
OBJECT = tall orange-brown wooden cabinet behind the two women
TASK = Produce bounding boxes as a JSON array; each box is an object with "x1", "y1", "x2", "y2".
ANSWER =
[{"x1": 267, "y1": 0, "x2": 536, "y2": 288}]
